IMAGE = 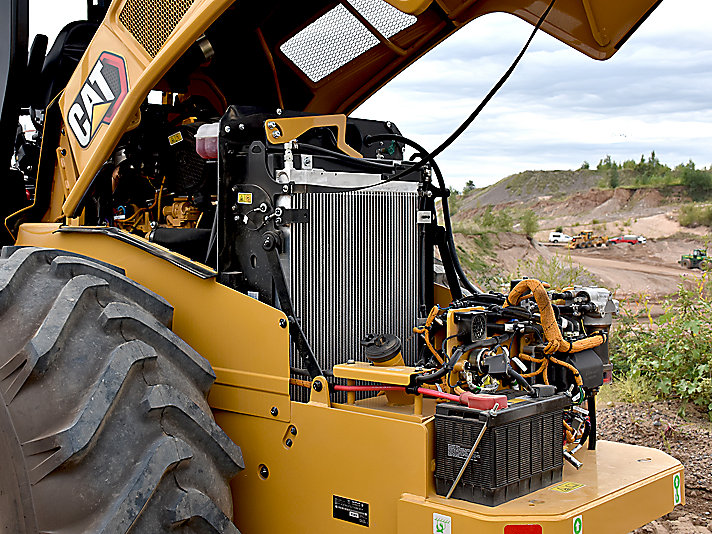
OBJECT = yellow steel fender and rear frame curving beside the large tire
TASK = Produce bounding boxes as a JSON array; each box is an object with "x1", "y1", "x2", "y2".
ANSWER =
[{"x1": 18, "y1": 224, "x2": 684, "y2": 534}]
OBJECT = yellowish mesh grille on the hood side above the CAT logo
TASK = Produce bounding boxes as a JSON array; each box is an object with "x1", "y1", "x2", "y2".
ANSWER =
[{"x1": 119, "y1": 0, "x2": 195, "y2": 57}]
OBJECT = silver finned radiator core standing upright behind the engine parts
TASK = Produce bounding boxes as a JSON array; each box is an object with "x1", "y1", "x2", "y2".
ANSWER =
[{"x1": 290, "y1": 191, "x2": 418, "y2": 400}]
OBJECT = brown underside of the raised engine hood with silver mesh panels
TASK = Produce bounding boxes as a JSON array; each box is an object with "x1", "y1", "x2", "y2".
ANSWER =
[{"x1": 232, "y1": 0, "x2": 662, "y2": 113}]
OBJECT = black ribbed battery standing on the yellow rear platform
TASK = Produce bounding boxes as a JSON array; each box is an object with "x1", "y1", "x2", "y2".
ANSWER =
[{"x1": 435, "y1": 394, "x2": 571, "y2": 506}]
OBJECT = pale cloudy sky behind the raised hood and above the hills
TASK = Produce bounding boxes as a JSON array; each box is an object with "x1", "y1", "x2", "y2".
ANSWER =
[{"x1": 30, "y1": 0, "x2": 712, "y2": 189}]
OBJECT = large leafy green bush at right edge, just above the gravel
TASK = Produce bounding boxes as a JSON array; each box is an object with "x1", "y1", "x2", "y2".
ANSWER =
[{"x1": 611, "y1": 280, "x2": 712, "y2": 420}]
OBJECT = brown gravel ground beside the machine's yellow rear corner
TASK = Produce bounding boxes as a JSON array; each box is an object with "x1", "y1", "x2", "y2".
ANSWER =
[{"x1": 598, "y1": 401, "x2": 712, "y2": 534}]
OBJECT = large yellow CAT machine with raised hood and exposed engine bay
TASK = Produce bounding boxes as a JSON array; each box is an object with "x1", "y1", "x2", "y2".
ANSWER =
[{"x1": 0, "y1": 0, "x2": 684, "y2": 534}]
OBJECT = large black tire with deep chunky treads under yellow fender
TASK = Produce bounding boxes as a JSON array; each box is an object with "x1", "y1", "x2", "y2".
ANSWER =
[{"x1": 0, "y1": 247, "x2": 244, "y2": 534}]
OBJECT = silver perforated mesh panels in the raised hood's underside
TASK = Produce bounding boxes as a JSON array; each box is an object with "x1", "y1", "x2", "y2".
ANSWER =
[{"x1": 280, "y1": 0, "x2": 417, "y2": 82}]
